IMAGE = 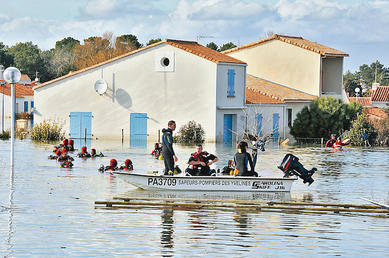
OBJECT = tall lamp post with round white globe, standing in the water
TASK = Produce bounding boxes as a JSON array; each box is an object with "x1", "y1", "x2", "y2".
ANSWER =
[{"x1": 4, "y1": 67, "x2": 21, "y2": 173}]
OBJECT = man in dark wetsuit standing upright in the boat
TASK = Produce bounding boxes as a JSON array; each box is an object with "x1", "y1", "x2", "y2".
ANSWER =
[{"x1": 162, "y1": 120, "x2": 178, "y2": 175}]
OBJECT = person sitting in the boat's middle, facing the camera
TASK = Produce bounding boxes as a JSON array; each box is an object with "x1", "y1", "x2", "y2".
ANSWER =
[{"x1": 185, "y1": 144, "x2": 219, "y2": 176}]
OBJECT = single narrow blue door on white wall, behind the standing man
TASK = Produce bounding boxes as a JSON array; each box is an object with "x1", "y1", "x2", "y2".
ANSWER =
[{"x1": 130, "y1": 113, "x2": 147, "y2": 147}]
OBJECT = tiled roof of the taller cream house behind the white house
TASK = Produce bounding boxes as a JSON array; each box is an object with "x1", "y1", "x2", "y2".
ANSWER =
[{"x1": 222, "y1": 34, "x2": 349, "y2": 56}]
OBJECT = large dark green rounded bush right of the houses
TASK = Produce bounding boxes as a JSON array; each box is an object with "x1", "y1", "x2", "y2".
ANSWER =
[{"x1": 290, "y1": 97, "x2": 362, "y2": 138}]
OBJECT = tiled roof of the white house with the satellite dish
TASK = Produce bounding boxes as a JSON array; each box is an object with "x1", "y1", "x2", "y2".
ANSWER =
[{"x1": 33, "y1": 39, "x2": 246, "y2": 90}]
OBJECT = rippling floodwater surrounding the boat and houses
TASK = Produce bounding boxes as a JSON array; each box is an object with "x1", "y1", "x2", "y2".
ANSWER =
[{"x1": 0, "y1": 140, "x2": 389, "y2": 257}]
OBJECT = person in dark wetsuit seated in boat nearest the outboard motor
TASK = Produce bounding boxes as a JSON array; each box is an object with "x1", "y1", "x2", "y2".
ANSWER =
[{"x1": 234, "y1": 142, "x2": 258, "y2": 176}]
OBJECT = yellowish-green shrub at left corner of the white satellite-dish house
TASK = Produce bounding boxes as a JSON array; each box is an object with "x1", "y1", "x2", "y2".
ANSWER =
[{"x1": 30, "y1": 118, "x2": 65, "y2": 141}]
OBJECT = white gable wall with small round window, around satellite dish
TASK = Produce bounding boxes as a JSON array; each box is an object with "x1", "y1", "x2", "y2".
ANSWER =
[{"x1": 35, "y1": 44, "x2": 246, "y2": 141}]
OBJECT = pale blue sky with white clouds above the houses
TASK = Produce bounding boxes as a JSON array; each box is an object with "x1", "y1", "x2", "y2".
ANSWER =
[{"x1": 0, "y1": 0, "x2": 389, "y2": 72}]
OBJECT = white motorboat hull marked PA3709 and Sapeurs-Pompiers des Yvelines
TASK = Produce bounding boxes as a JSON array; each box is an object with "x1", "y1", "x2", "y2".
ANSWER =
[{"x1": 113, "y1": 171, "x2": 297, "y2": 192}]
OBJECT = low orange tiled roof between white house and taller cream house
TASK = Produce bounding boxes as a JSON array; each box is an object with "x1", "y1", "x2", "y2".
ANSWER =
[{"x1": 246, "y1": 75, "x2": 317, "y2": 102}]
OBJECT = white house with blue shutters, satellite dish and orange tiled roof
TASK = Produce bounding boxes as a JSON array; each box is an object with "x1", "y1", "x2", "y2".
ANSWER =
[{"x1": 33, "y1": 40, "x2": 246, "y2": 145}]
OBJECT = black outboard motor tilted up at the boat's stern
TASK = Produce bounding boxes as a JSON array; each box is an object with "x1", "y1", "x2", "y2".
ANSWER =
[{"x1": 278, "y1": 153, "x2": 317, "y2": 186}]
